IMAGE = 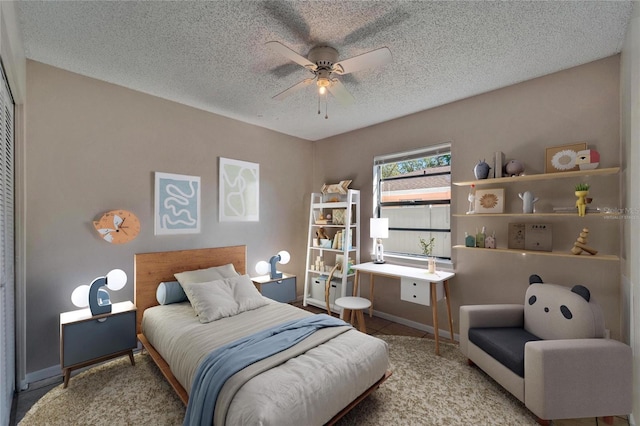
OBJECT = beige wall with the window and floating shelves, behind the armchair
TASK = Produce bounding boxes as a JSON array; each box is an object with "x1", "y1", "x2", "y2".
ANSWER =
[{"x1": 314, "y1": 56, "x2": 620, "y2": 337}]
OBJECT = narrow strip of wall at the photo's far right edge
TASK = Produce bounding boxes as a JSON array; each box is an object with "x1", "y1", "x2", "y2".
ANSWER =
[{"x1": 620, "y1": 3, "x2": 640, "y2": 424}]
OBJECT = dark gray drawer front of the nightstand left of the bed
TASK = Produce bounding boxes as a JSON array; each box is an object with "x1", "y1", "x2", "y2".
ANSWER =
[{"x1": 62, "y1": 311, "x2": 137, "y2": 368}]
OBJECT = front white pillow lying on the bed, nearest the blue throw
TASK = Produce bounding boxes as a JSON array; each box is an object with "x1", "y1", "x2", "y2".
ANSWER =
[{"x1": 183, "y1": 280, "x2": 238, "y2": 324}]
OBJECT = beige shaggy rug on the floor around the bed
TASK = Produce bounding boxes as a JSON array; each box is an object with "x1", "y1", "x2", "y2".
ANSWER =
[{"x1": 20, "y1": 335, "x2": 537, "y2": 426}]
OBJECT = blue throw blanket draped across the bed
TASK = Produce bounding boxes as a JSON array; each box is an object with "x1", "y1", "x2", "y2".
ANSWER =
[{"x1": 184, "y1": 314, "x2": 349, "y2": 426}]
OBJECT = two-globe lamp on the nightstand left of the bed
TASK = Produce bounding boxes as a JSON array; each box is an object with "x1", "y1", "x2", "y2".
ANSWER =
[{"x1": 71, "y1": 269, "x2": 127, "y2": 315}]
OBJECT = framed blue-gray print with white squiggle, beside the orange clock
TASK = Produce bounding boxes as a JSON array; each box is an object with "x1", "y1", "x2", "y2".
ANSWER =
[{"x1": 155, "y1": 172, "x2": 200, "y2": 235}]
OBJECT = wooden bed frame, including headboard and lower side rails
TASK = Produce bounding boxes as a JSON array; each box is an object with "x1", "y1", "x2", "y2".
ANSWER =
[{"x1": 133, "y1": 246, "x2": 391, "y2": 424}]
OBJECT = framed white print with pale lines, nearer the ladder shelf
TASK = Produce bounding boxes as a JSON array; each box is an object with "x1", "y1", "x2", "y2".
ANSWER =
[{"x1": 220, "y1": 157, "x2": 260, "y2": 222}]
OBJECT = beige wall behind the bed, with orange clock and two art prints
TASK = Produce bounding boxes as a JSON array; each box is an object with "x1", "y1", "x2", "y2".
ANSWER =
[{"x1": 26, "y1": 62, "x2": 312, "y2": 373}]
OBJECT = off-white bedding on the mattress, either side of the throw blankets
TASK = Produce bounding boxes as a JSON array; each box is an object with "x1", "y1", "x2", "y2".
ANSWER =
[{"x1": 142, "y1": 299, "x2": 389, "y2": 425}]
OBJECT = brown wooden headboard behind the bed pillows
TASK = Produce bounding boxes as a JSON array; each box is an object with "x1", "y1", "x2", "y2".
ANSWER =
[{"x1": 133, "y1": 246, "x2": 247, "y2": 334}]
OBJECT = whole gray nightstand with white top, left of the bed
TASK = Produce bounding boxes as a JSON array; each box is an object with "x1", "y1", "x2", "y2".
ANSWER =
[{"x1": 60, "y1": 302, "x2": 138, "y2": 388}]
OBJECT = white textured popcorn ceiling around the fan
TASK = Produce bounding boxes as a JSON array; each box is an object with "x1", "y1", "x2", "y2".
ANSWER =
[{"x1": 17, "y1": 0, "x2": 633, "y2": 140}]
